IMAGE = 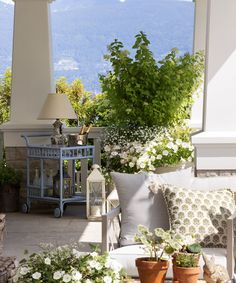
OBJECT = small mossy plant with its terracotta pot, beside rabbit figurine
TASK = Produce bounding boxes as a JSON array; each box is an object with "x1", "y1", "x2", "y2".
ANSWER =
[{"x1": 172, "y1": 236, "x2": 201, "y2": 283}]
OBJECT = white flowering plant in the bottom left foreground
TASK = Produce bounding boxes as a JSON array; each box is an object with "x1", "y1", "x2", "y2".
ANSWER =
[{"x1": 15, "y1": 245, "x2": 125, "y2": 283}]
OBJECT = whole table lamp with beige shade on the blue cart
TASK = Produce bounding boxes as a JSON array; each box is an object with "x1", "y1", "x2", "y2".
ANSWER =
[{"x1": 38, "y1": 93, "x2": 77, "y2": 145}]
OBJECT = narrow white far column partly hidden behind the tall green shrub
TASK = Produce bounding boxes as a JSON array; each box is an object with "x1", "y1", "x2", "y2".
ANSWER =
[{"x1": 190, "y1": 0, "x2": 207, "y2": 129}]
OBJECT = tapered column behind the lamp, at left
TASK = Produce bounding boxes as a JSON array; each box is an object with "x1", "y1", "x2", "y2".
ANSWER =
[{"x1": 1, "y1": 0, "x2": 54, "y2": 146}]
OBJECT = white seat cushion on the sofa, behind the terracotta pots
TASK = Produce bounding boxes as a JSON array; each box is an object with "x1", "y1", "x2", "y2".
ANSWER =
[{"x1": 109, "y1": 245, "x2": 226, "y2": 279}]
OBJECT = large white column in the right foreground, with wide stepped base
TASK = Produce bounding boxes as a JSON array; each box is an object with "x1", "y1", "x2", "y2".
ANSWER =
[{"x1": 192, "y1": 0, "x2": 236, "y2": 170}]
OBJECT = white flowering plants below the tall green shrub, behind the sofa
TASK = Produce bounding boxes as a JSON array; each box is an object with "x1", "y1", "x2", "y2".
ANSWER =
[{"x1": 103, "y1": 124, "x2": 194, "y2": 173}]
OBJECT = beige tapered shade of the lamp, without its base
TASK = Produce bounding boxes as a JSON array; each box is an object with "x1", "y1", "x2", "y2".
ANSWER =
[{"x1": 38, "y1": 93, "x2": 77, "y2": 120}]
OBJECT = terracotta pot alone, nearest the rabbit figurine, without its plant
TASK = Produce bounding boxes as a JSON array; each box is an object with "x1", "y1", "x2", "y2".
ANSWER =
[{"x1": 172, "y1": 265, "x2": 200, "y2": 283}]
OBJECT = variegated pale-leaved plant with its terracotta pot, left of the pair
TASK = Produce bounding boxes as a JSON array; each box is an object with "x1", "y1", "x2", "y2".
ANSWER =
[{"x1": 135, "y1": 225, "x2": 180, "y2": 283}]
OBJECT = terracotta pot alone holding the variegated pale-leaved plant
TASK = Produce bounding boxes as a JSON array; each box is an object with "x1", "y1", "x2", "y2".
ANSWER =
[{"x1": 135, "y1": 258, "x2": 169, "y2": 283}]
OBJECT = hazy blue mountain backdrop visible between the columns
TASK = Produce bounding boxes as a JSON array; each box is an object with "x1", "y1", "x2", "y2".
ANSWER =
[{"x1": 0, "y1": 0, "x2": 194, "y2": 93}]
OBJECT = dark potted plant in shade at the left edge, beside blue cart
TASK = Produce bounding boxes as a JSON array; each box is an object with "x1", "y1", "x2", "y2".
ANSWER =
[{"x1": 0, "y1": 161, "x2": 22, "y2": 212}]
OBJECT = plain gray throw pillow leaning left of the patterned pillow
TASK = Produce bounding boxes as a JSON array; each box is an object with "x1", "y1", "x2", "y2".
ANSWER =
[{"x1": 111, "y1": 172, "x2": 169, "y2": 246}]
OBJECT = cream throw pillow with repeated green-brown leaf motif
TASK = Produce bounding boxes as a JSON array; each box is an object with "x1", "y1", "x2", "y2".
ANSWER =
[{"x1": 162, "y1": 185, "x2": 235, "y2": 248}]
